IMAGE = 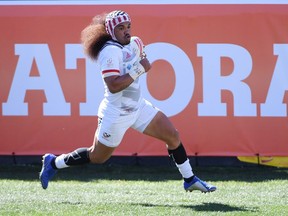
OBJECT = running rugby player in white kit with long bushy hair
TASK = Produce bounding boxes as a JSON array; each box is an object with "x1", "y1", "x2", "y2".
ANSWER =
[{"x1": 39, "y1": 10, "x2": 216, "y2": 192}]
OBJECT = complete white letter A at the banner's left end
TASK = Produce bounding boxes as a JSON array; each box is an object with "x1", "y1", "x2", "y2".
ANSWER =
[{"x1": 3, "y1": 44, "x2": 70, "y2": 116}]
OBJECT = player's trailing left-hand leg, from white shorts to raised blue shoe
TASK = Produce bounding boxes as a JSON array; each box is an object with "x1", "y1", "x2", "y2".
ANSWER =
[{"x1": 39, "y1": 115, "x2": 133, "y2": 189}]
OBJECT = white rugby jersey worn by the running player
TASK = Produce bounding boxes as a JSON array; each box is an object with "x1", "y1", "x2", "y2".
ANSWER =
[{"x1": 98, "y1": 41, "x2": 142, "y2": 115}]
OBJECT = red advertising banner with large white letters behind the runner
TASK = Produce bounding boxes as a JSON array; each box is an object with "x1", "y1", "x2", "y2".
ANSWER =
[{"x1": 0, "y1": 4, "x2": 288, "y2": 156}]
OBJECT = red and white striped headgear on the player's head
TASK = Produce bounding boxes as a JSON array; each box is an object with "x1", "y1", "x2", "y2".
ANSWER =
[{"x1": 105, "y1": 10, "x2": 131, "y2": 40}]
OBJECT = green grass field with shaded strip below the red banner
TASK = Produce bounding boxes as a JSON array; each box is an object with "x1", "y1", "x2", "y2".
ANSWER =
[{"x1": 0, "y1": 165, "x2": 288, "y2": 216}]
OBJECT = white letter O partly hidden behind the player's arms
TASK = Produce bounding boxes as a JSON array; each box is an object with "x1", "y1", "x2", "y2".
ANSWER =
[{"x1": 140, "y1": 43, "x2": 195, "y2": 116}]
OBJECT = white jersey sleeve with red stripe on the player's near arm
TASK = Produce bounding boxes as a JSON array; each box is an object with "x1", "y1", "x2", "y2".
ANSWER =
[{"x1": 99, "y1": 46, "x2": 122, "y2": 78}]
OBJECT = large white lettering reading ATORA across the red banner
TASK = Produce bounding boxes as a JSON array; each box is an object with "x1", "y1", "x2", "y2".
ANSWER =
[{"x1": 2, "y1": 43, "x2": 288, "y2": 117}]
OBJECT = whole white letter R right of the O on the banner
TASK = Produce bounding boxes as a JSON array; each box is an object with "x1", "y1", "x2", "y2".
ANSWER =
[{"x1": 197, "y1": 44, "x2": 257, "y2": 116}]
